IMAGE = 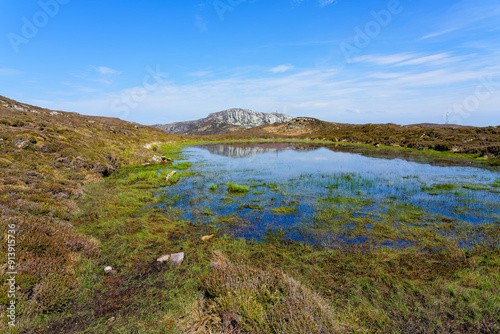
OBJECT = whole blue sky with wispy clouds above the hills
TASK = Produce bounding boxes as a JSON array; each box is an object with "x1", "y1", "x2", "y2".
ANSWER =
[{"x1": 0, "y1": 0, "x2": 500, "y2": 126}]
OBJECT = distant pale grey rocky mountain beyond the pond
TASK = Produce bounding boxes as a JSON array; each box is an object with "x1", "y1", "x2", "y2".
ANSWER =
[{"x1": 153, "y1": 108, "x2": 293, "y2": 135}]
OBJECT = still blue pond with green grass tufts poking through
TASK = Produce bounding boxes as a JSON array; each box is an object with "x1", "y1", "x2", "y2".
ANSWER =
[{"x1": 158, "y1": 143, "x2": 500, "y2": 245}]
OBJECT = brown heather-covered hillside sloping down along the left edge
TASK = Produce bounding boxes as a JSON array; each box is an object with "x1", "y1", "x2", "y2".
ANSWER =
[{"x1": 0, "y1": 96, "x2": 181, "y2": 333}]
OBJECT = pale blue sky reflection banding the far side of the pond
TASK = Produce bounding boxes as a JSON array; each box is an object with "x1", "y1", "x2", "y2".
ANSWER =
[{"x1": 190, "y1": 145, "x2": 499, "y2": 183}]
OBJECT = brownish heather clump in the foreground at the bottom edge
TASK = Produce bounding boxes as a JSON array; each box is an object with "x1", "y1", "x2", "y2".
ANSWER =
[{"x1": 193, "y1": 251, "x2": 346, "y2": 334}]
